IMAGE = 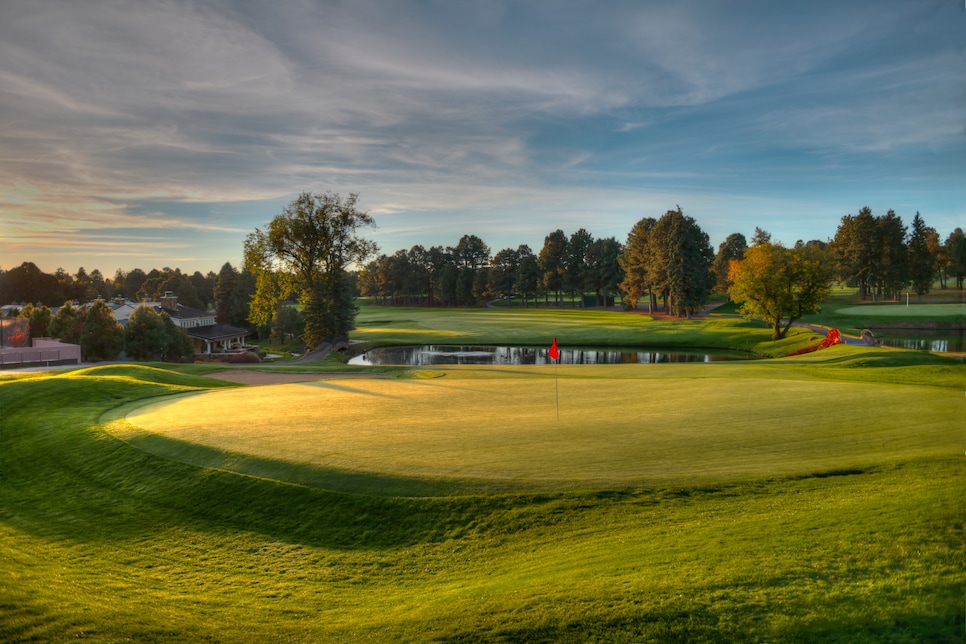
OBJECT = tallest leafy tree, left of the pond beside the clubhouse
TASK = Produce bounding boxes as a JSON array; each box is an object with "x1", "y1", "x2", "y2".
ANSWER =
[{"x1": 245, "y1": 192, "x2": 377, "y2": 347}]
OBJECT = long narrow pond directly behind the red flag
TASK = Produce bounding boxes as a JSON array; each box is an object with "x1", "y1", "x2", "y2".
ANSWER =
[{"x1": 349, "y1": 345, "x2": 757, "y2": 367}]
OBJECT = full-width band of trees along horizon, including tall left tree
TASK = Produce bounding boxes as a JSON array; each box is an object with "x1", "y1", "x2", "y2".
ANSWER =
[{"x1": 0, "y1": 192, "x2": 966, "y2": 347}]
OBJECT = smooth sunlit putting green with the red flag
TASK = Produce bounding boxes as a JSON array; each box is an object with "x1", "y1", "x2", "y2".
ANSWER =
[{"x1": 127, "y1": 374, "x2": 963, "y2": 489}]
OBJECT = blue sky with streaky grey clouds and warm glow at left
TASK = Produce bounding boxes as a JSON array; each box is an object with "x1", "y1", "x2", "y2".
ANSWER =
[{"x1": 0, "y1": 0, "x2": 966, "y2": 276}]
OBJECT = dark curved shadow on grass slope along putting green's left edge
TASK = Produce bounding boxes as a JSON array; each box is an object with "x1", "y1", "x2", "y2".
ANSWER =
[{"x1": 0, "y1": 377, "x2": 520, "y2": 549}]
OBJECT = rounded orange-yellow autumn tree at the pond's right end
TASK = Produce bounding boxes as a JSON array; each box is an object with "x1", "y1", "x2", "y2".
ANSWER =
[{"x1": 728, "y1": 242, "x2": 833, "y2": 340}]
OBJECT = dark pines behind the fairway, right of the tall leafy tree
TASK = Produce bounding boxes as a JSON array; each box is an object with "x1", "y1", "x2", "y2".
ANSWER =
[{"x1": 359, "y1": 207, "x2": 966, "y2": 317}]
